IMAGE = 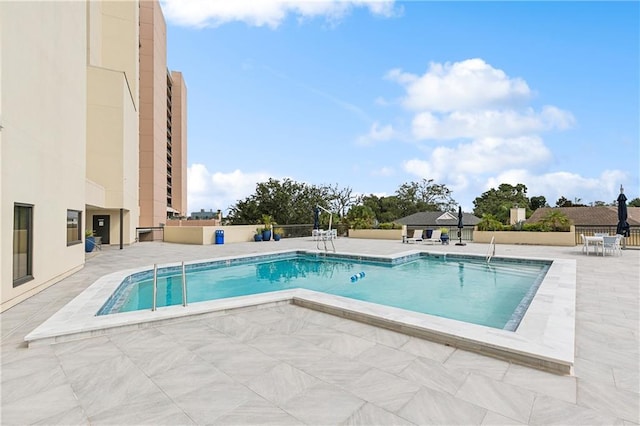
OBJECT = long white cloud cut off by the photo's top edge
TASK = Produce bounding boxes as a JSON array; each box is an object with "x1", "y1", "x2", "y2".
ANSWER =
[{"x1": 161, "y1": 0, "x2": 399, "y2": 28}]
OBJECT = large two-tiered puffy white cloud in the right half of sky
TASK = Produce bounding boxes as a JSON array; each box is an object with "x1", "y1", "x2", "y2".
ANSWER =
[{"x1": 386, "y1": 59, "x2": 575, "y2": 140}]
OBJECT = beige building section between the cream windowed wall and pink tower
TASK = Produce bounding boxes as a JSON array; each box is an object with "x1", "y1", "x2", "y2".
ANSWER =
[{"x1": 85, "y1": 1, "x2": 139, "y2": 244}]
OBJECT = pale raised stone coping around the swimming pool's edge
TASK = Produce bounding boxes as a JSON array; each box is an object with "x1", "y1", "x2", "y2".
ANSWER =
[{"x1": 24, "y1": 249, "x2": 576, "y2": 374}]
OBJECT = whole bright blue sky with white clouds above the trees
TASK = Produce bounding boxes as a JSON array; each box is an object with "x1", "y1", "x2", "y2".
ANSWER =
[{"x1": 161, "y1": 0, "x2": 640, "y2": 212}]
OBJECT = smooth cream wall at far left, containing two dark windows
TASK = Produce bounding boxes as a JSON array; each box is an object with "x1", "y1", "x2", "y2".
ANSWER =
[{"x1": 0, "y1": 2, "x2": 87, "y2": 311}]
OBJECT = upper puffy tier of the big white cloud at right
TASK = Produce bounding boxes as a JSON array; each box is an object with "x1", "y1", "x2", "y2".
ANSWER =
[{"x1": 387, "y1": 59, "x2": 531, "y2": 112}]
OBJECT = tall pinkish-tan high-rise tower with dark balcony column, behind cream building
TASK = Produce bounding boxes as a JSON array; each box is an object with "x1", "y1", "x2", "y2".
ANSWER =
[{"x1": 140, "y1": 1, "x2": 187, "y2": 233}]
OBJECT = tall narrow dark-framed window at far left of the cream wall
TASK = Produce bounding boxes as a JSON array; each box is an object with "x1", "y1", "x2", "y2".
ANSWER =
[{"x1": 13, "y1": 204, "x2": 33, "y2": 287}]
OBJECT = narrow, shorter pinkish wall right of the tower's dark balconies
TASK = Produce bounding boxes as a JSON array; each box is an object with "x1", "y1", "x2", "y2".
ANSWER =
[{"x1": 171, "y1": 71, "x2": 188, "y2": 216}]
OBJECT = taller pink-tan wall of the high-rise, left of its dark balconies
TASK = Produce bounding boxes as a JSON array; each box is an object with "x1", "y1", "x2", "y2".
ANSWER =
[{"x1": 139, "y1": 0, "x2": 167, "y2": 227}]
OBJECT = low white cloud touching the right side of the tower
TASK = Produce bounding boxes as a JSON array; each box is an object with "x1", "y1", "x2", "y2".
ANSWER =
[{"x1": 187, "y1": 163, "x2": 272, "y2": 213}]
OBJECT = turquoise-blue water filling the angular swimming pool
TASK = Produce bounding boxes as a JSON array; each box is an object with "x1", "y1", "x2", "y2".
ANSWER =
[{"x1": 98, "y1": 253, "x2": 550, "y2": 330}]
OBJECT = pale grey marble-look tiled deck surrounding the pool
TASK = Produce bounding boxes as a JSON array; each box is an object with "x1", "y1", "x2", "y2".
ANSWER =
[{"x1": 0, "y1": 238, "x2": 640, "y2": 425}]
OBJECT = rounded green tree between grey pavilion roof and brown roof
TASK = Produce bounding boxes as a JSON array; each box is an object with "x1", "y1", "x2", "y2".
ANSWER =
[{"x1": 473, "y1": 183, "x2": 531, "y2": 224}]
